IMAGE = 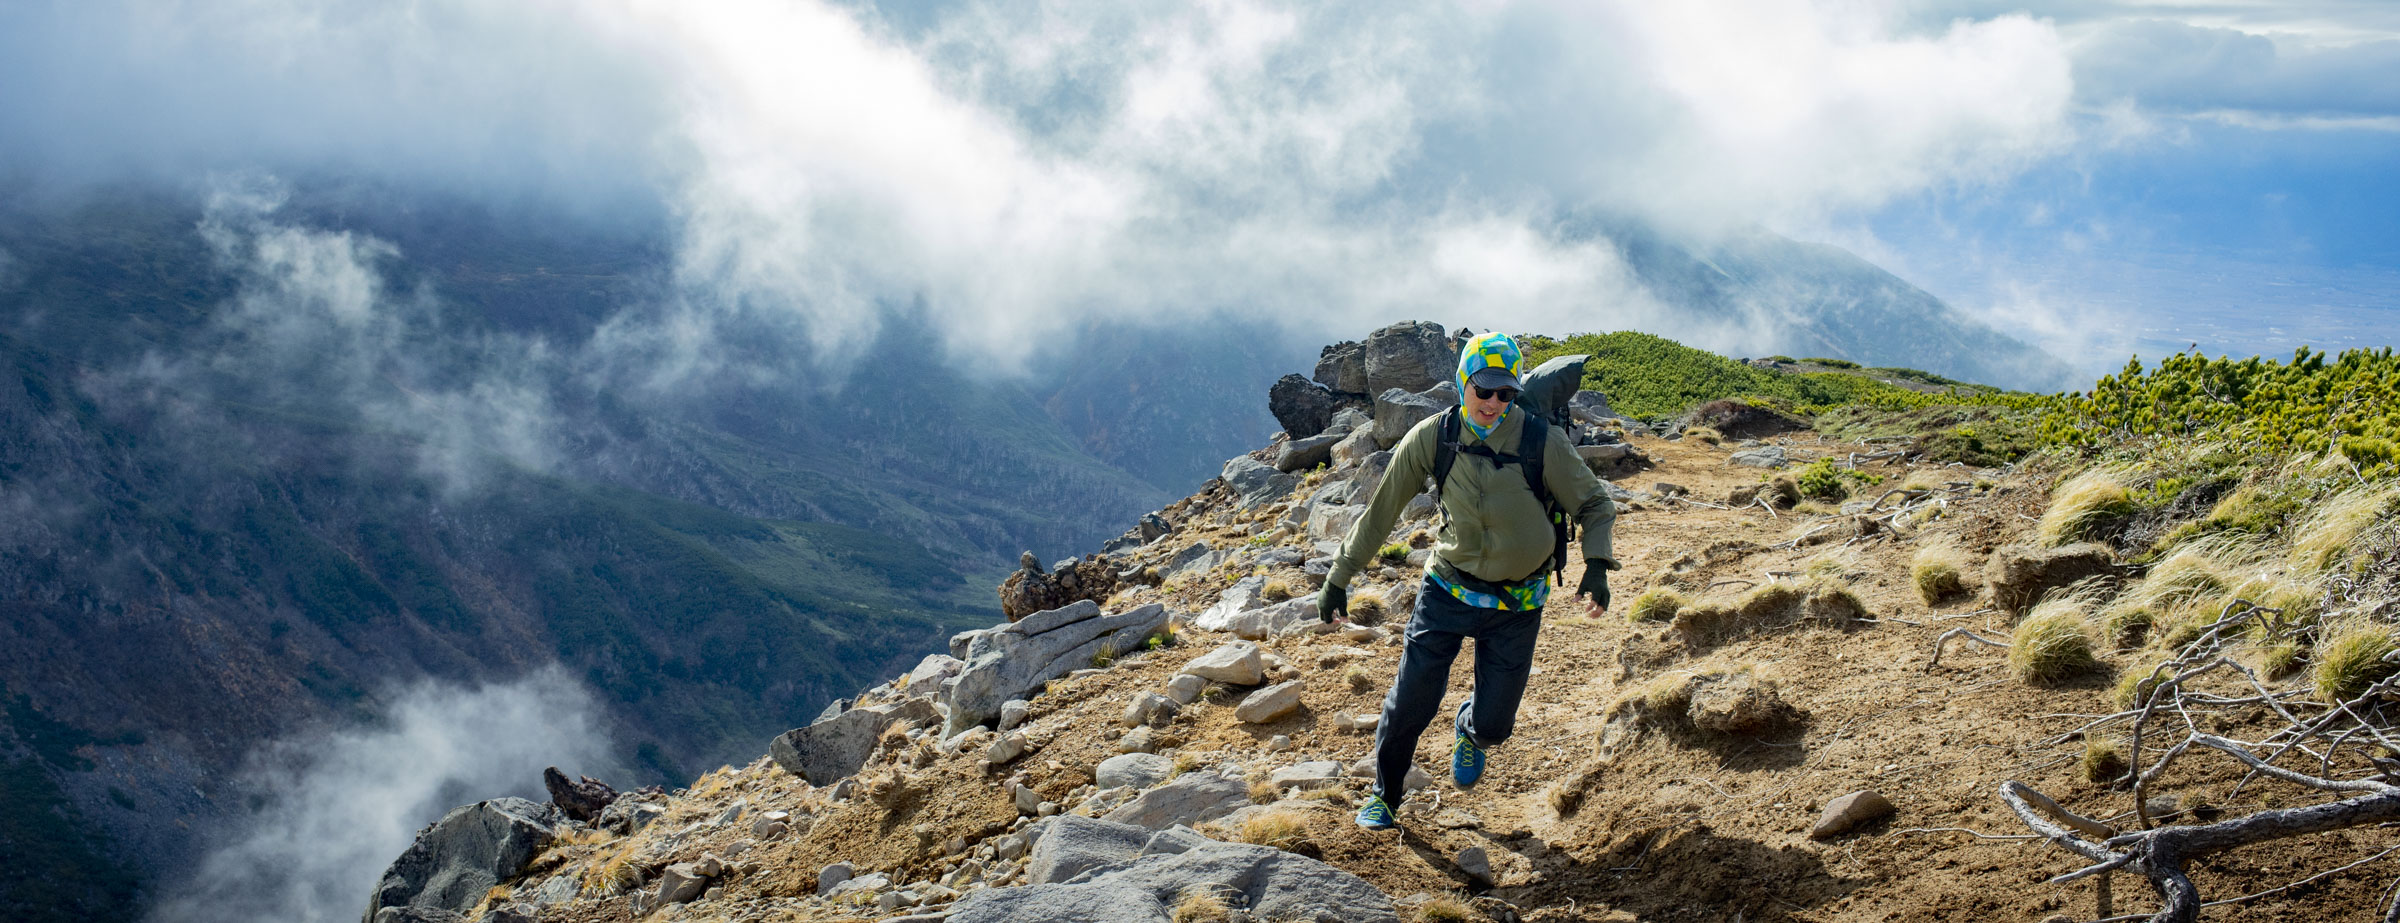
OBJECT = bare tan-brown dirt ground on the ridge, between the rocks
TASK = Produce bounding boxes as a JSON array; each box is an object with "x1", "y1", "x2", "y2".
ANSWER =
[{"x1": 545, "y1": 434, "x2": 2400, "y2": 923}]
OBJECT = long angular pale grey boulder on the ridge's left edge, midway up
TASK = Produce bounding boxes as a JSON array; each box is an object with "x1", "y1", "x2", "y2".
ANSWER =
[{"x1": 940, "y1": 602, "x2": 1169, "y2": 733}]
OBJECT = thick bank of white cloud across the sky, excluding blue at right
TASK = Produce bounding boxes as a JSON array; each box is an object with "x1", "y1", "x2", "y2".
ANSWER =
[{"x1": 0, "y1": 0, "x2": 2102, "y2": 364}]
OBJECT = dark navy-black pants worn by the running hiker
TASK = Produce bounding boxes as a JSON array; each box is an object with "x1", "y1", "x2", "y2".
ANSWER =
[{"x1": 1375, "y1": 578, "x2": 1541, "y2": 806}]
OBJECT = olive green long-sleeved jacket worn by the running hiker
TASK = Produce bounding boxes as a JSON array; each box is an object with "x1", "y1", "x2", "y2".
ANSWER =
[{"x1": 1325, "y1": 408, "x2": 1618, "y2": 587}]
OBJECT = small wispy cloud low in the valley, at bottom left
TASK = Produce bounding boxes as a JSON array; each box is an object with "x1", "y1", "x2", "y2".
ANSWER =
[{"x1": 149, "y1": 669, "x2": 607, "y2": 923}]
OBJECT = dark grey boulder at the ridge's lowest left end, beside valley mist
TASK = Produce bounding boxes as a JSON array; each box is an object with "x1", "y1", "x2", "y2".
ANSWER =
[{"x1": 365, "y1": 798, "x2": 566, "y2": 921}]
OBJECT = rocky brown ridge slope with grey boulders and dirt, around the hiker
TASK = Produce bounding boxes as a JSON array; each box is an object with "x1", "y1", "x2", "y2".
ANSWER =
[{"x1": 370, "y1": 321, "x2": 2390, "y2": 923}]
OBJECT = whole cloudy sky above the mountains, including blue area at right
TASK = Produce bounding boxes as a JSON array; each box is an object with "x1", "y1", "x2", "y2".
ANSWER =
[{"x1": 0, "y1": 0, "x2": 2400, "y2": 383}]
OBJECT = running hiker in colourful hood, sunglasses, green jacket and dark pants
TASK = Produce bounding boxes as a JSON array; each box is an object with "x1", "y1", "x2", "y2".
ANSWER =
[{"x1": 1318, "y1": 333, "x2": 1618, "y2": 830}]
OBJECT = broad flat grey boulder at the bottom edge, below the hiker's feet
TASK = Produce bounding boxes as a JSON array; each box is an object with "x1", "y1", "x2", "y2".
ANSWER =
[{"x1": 950, "y1": 837, "x2": 1399, "y2": 923}]
